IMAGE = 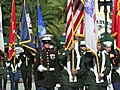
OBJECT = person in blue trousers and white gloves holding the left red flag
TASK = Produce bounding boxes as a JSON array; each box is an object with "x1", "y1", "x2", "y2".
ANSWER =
[{"x1": 6, "y1": 51, "x2": 22, "y2": 90}]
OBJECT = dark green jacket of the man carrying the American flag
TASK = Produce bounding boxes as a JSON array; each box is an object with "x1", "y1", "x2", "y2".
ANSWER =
[{"x1": 58, "y1": 48, "x2": 85, "y2": 87}]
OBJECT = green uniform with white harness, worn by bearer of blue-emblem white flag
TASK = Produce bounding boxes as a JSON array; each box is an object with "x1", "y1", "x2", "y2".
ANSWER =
[{"x1": 85, "y1": 52, "x2": 110, "y2": 90}]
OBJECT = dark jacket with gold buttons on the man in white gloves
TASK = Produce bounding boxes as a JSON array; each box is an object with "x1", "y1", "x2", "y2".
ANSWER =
[{"x1": 34, "y1": 49, "x2": 59, "y2": 88}]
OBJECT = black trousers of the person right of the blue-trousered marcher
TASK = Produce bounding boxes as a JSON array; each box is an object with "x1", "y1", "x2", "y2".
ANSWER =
[{"x1": 21, "y1": 70, "x2": 32, "y2": 90}]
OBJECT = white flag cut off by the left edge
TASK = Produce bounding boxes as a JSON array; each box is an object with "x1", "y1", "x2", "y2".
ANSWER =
[{"x1": 0, "y1": 5, "x2": 4, "y2": 52}]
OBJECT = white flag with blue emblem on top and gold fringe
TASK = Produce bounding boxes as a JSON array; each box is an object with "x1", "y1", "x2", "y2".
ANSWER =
[{"x1": 85, "y1": 0, "x2": 98, "y2": 54}]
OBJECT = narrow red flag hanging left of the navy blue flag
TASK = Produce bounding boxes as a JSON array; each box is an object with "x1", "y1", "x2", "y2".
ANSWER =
[{"x1": 8, "y1": 0, "x2": 16, "y2": 60}]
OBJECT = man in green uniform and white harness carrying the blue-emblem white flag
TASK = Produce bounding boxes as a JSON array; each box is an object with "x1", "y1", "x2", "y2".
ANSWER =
[{"x1": 85, "y1": 42, "x2": 111, "y2": 90}]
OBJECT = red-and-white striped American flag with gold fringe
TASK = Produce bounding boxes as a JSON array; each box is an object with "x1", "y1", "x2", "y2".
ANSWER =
[{"x1": 65, "y1": 0, "x2": 84, "y2": 48}]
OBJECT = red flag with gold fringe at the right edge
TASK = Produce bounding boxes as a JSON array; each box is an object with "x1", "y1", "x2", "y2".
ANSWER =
[{"x1": 111, "y1": 0, "x2": 120, "y2": 51}]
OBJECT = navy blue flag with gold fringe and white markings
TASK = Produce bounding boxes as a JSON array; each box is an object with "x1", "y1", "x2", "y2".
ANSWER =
[{"x1": 20, "y1": 0, "x2": 36, "y2": 55}]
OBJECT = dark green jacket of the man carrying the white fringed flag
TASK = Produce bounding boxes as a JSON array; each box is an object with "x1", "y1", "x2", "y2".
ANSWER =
[{"x1": 85, "y1": 52, "x2": 111, "y2": 90}]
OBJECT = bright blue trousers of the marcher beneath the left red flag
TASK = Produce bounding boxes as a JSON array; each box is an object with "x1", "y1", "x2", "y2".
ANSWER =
[{"x1": 9, "y1": 71, "x2": 19, "y2": 90}]
